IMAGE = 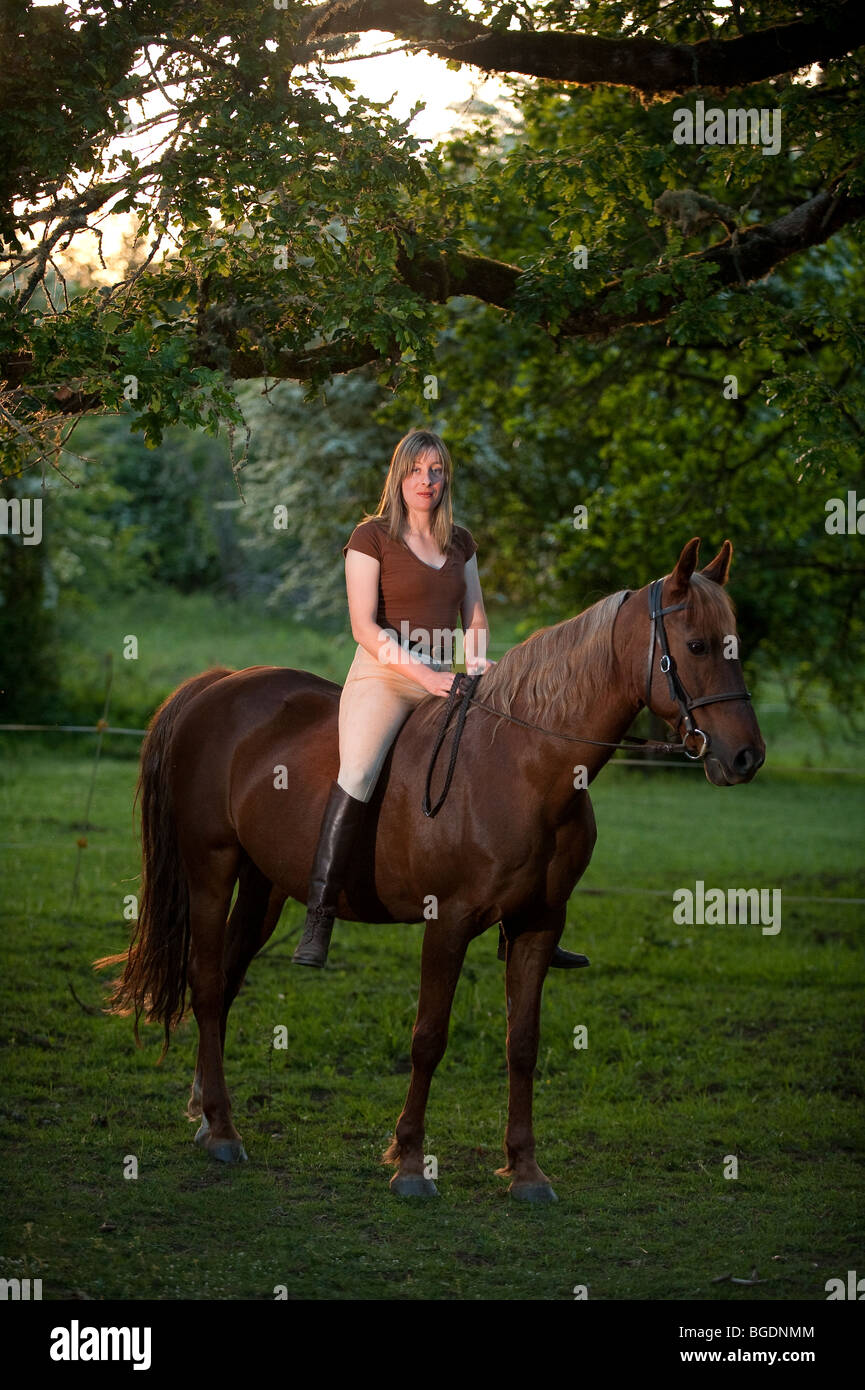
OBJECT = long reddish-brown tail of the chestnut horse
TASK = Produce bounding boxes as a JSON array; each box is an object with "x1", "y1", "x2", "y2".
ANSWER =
[{"x1": 93, "y1": 666, "x2": 231, "y2": 1062}]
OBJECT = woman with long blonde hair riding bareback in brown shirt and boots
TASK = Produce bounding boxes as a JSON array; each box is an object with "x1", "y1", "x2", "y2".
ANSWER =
[{"x1": 293, "y1": 430, "x2": 588, "y2": 967}]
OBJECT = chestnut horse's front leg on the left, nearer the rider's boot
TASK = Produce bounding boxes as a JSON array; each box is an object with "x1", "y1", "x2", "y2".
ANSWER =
[{"x1": 382, "y1": 922, "x2": 474, "y2": 1197}]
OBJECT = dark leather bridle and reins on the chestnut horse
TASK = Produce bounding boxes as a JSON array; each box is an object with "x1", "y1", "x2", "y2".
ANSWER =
[{"x1": 421, "y1": 575, "x2": 751, "y2": 817}]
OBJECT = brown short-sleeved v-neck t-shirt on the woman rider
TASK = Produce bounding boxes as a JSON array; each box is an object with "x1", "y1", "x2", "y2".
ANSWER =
[{"x1": 342, "y1": 517, "x2": 477, "y2": 637}]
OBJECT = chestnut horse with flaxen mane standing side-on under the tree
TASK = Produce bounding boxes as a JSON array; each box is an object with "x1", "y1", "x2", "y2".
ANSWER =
[{"x1": 100, "y1": 539, "x2": 765, "y2": 1201}]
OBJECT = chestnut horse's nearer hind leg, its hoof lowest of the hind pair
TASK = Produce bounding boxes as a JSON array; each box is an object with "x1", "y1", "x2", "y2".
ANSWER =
[{"x1": 189, "y1": 845, "x2": 246, "y2": 1163}]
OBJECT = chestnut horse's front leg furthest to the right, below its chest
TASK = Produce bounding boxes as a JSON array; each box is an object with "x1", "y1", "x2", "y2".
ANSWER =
[{"x1": 496, "y1": 909, "x2": 565, "y2": 1202}]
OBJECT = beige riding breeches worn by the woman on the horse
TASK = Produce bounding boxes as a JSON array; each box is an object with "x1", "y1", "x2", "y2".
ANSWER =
[{"x1": 337, "y1": 646, "x2": 452, "y2": 801}]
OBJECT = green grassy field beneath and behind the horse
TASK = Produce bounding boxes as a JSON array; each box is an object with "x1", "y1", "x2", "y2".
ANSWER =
[{"x1": 0, "y1": 589, "x2": 865, "y2": 1302}]
